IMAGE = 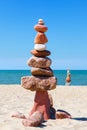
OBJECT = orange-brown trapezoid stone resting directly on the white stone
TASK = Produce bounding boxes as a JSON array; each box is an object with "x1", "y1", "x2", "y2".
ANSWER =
[{"x1": 34, "y1": 32, "x2": 48, "y2": 44}]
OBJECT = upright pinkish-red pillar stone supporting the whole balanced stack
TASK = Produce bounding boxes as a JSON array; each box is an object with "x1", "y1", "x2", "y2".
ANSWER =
[{"x1": 30, "y1": 91, "x2": 50, "y2": 120}]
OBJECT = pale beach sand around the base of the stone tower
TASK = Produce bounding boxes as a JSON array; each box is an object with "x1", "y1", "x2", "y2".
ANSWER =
[{"x1": 0, "y1": 85, "x2": 87, "y2": 130}]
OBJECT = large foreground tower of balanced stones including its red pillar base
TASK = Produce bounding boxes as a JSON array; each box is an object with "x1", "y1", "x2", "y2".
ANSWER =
[{"x1": 21, "y1": 19, "x2": 57, "y2": 120}]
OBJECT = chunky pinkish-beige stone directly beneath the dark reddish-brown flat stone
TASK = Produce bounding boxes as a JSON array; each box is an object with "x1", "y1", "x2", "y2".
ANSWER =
[{"x1": 27, "y1": 56, "x2": 52, "y2": 68}]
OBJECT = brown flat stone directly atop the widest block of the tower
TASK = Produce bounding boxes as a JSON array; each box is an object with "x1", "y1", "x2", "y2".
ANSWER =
[{"x1": 31, "y1": 67, "x2": 53, "y2": 76}]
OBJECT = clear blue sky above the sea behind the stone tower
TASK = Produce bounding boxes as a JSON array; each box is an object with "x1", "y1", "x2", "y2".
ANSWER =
[{"x1": 0, "y1": 0, "x2": 87, "y2": 70}]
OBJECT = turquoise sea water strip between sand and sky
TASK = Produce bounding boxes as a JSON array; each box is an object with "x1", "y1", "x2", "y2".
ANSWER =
[{"x1": 0, "y1": 70, "x2": 87, "y2": 86}]
